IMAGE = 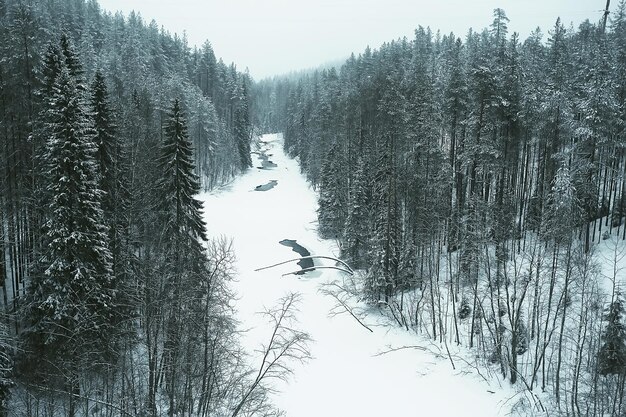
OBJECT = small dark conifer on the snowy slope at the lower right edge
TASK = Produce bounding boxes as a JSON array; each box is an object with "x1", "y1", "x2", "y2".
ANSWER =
[{"x1": 598, "y1": 293, "x2": 626, "y2": 375}]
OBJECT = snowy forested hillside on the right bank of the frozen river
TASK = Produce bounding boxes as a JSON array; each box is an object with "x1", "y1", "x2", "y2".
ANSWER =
[{"x1": 255, "y1": 5, "x2": 626, "y2": 416}]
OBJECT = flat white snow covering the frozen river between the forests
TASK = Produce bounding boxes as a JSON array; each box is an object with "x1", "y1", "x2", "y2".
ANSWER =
[{"x1": 201, "y1": 135, "x2": 524, "y2": 417}]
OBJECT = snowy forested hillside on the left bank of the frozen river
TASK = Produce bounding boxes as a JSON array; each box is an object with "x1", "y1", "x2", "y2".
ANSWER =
[{"x1": 0, "y1": 0, "x2": 262, "y2": 416}]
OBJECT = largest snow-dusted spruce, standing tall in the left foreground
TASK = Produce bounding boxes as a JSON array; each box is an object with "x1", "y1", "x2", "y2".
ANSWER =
[{"x1": 25, "y1": 65, "x2": 115, "y2": 380}]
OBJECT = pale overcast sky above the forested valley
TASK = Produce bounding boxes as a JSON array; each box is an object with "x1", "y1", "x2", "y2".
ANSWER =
[{"x1": 99, "y1": 0, "x2": 617, "y2": 80}]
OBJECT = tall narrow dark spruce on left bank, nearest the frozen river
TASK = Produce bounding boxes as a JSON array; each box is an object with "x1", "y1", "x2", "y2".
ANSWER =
[{"x1": 150, "y1": 99, "x2": 207, "y2": 416}]
